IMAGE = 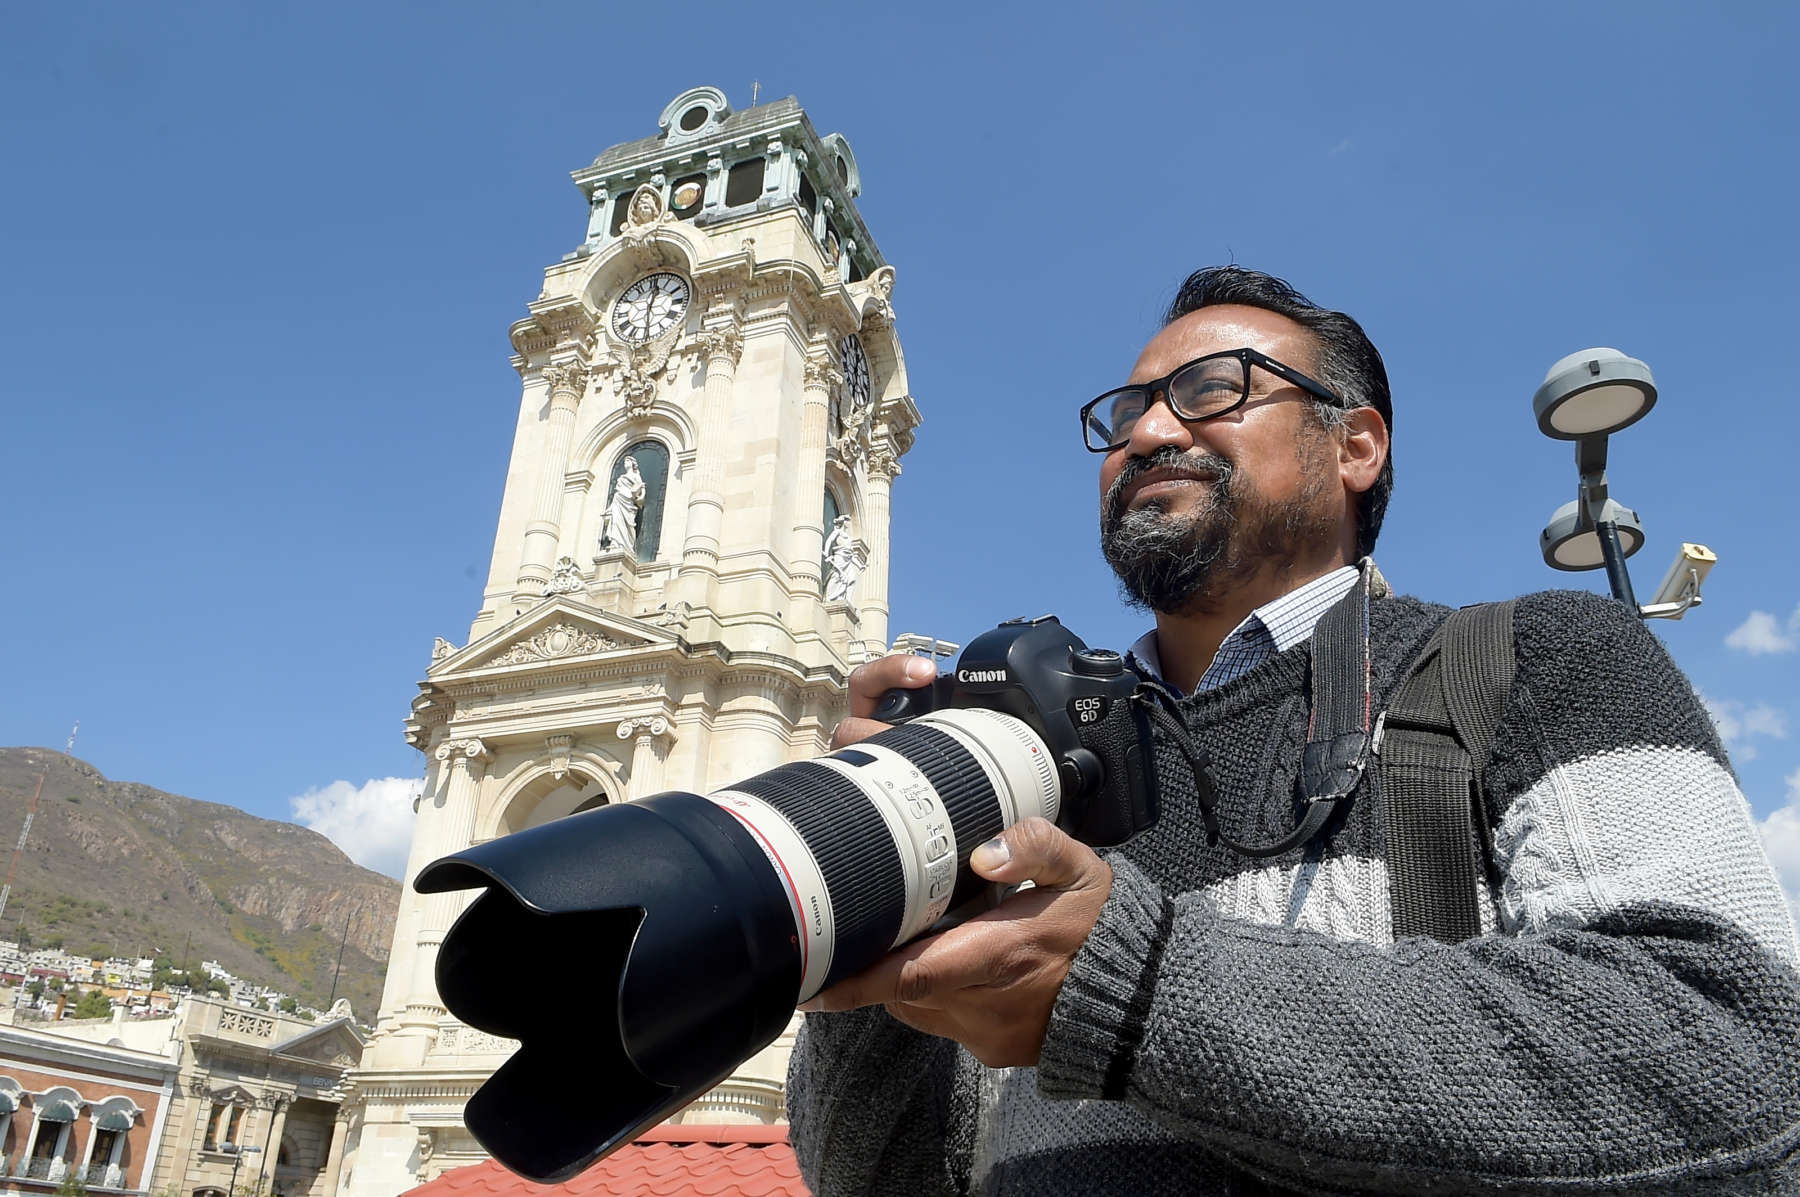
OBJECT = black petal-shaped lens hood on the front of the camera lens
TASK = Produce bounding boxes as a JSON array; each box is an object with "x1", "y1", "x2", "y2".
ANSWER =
[{"x1": 414, "y1": 792, "x2": 801, "y2": 1183}]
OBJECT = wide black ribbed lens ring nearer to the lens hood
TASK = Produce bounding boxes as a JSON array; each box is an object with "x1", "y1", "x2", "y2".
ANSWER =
[{"x1": 729, "y1": 761, "x2": 905, "y2": 985}]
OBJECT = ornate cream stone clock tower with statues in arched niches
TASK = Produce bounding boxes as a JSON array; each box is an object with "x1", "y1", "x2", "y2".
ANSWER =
[{"x1": 344, "y1": 86, "x2": 920, "y2": 1197}]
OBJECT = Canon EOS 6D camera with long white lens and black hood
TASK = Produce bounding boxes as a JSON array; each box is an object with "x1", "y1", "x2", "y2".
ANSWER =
[{"x1": 416, "y1": 616, "x2": 1156, "y2": 1181}]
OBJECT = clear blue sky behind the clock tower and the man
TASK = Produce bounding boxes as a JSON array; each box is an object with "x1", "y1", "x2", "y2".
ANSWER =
[{"x1": 0, "y1": 4, "x2": 1800, "y2": 914}]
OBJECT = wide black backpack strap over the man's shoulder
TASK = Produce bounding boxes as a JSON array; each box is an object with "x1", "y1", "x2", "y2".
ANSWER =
[{"x1": 1379, "y1": 603, "x2": 1514, "y2": 943}]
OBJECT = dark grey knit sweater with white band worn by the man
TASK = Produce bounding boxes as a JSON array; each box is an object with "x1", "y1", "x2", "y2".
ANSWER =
[{"x1": 788, "y1": 592, "x2": 1800, "y2": 1197}]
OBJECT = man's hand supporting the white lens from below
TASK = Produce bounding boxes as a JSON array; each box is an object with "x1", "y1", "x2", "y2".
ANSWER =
[{"x1": 801, "y1": 819, "x2": 1112, "y2": 1067}]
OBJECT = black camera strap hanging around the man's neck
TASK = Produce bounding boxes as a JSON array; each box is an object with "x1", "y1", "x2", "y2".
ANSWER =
[{"x1": 1134, "y1": 558, "x2": 1373, "y2": 857}]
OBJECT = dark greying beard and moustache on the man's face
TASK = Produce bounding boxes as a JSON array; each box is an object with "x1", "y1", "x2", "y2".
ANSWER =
[{"x1": 1100, "y1": 445, "x2": 1332, "y2": 614}]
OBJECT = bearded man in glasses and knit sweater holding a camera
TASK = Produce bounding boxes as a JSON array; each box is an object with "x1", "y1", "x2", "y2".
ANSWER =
[{"x1": 788, "y1": 268, "x2": 1800, "y2": 1197}]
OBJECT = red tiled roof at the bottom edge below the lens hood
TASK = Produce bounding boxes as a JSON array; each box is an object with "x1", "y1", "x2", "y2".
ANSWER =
[{"x1": 403, "y1": 1125, "x2": 808, "y2": 1197}]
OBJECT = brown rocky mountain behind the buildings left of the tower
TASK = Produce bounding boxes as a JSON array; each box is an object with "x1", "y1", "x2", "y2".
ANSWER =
[{"x1": 0, "y1": 749, "x2": 400, "y2": 1022}]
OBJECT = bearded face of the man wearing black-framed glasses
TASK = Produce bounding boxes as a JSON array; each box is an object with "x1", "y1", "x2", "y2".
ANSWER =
[{"x1": 1100, "y1": 306, "x2": 1343, "y2": 614}]
